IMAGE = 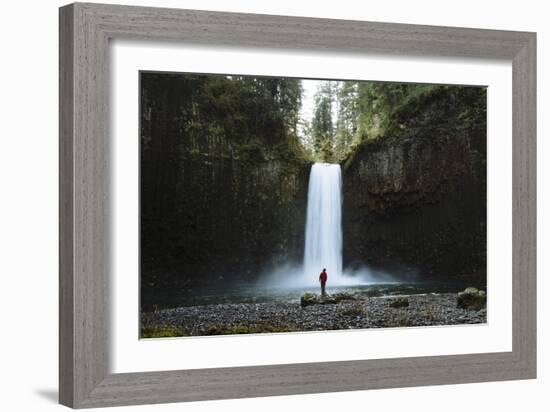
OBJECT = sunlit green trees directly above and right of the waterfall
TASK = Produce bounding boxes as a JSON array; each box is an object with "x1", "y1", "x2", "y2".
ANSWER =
[{"x1": 300, "y1": 81, "x2": 486, "y2": 162}]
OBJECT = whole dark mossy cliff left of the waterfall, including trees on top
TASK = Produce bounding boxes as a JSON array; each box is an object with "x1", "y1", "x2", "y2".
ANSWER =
[{"x1": 141, "y1": 73, "x2": 309, "y2": 303}]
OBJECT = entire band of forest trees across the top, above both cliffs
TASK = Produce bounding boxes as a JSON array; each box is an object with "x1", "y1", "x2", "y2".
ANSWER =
[{"x1": 143, "y1": 73, "x2": 486, "y2": 163}]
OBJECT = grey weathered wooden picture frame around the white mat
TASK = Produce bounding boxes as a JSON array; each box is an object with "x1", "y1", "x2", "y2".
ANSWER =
[{"x1": 59, "y1": 3, "x2": 536, "y2": 408}]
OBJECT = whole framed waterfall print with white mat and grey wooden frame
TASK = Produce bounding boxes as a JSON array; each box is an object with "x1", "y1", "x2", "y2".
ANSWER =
[{"x1": 60, "y1": 3, "x2": 536, "y2": 408}]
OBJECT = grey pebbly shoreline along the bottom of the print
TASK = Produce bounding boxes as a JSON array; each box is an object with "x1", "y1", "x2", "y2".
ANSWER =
[{"x1": 141, "y1": 293, "x2": 487, "y2": 338}]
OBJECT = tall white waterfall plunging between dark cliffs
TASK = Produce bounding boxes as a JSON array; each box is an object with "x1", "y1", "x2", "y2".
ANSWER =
[{"x1": 303, "y1": 163, "x2": 344, "y2": 286}]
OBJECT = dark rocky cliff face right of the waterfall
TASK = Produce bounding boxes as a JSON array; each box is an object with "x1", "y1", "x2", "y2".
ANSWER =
[{"x1": 343, "y1": 88, "x2": 486, "y2": 276}]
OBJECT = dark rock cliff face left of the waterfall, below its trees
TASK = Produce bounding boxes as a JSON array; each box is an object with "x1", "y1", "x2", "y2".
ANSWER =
[{"x1": 140, "y1": 75, "x2": 309, "y2": 290}]
